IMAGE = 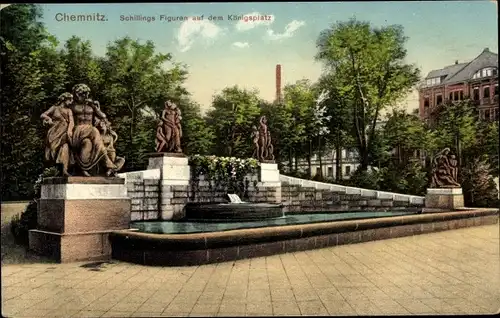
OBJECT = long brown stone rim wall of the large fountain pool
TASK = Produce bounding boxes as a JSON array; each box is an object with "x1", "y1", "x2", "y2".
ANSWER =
[{"x1": 110, "y1": 209, "x2": 498, "y2": 266}]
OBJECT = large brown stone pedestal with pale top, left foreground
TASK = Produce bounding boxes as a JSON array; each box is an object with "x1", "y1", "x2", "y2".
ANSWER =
[{"x1": 29, "y1": 177, "x2": 130, "y2": 263}]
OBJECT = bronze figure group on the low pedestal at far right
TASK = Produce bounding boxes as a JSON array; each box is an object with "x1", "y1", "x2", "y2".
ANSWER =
[{"x1": 431, "y1": 148, "x2": 460, "y2": 188}]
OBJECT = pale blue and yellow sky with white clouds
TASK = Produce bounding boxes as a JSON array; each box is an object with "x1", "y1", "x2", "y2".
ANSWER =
[{"x1": 34, "y1": 0, "x2": 498, "y2": 111}]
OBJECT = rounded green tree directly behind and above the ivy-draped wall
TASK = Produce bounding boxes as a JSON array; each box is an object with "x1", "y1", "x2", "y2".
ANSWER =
[{"x1": 207, "y1": 86, "x2": 261, "y2": 158}]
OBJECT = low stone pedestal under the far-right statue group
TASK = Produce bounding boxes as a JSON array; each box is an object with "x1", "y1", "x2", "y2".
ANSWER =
[{"x1": 423, "y1": 188, "x2": 464, "y2": 212}]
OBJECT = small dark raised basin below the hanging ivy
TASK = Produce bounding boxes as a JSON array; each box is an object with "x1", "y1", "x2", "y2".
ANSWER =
[{"x1": 185, "y1": 202, "x2": 283, "y2": 222}]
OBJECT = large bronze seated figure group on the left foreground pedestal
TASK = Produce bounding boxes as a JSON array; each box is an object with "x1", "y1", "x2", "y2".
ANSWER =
[{"x1": 41, "y1": 84, "x2": 125, "y2": 177}]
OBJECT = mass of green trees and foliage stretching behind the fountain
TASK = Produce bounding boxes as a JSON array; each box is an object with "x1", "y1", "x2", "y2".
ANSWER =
[{"x1": 0, "y1": 4, "x2": 499, "y2": 204}]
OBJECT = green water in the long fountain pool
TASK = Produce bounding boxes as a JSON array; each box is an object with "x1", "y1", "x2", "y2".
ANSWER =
[{"x1": 130, "y1": 211, "x2": 416, "y2": 234}]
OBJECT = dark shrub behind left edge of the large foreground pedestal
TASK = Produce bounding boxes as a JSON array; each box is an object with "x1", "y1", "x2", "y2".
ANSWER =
[{"x1": 10, "y1": 168, "x2": 58, "y2": 245}]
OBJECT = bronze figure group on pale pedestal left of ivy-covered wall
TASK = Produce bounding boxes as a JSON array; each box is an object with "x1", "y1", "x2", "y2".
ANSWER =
[{"x1": 156, "y1": 101, "x2": 182, "y2": 153}]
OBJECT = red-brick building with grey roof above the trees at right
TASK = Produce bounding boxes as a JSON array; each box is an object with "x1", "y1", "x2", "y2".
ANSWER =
[{"x1": 419, "y1": 48, "x2": 499, "y2": 121}]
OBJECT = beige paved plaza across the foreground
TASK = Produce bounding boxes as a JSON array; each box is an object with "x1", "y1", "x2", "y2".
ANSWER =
[{"x1": 2, "y1": 224, "x2": 500, "y2": 317}]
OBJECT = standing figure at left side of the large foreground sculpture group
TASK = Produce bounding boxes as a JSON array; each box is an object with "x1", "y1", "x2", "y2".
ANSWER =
[{"x1": 40, "y1": 93, "x2": 74, "y2": 176}]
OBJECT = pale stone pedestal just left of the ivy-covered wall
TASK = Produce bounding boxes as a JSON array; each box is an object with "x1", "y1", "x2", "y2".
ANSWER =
[{"x1": 148, "y1": 153, "x2": 191, "y2": 220}]
